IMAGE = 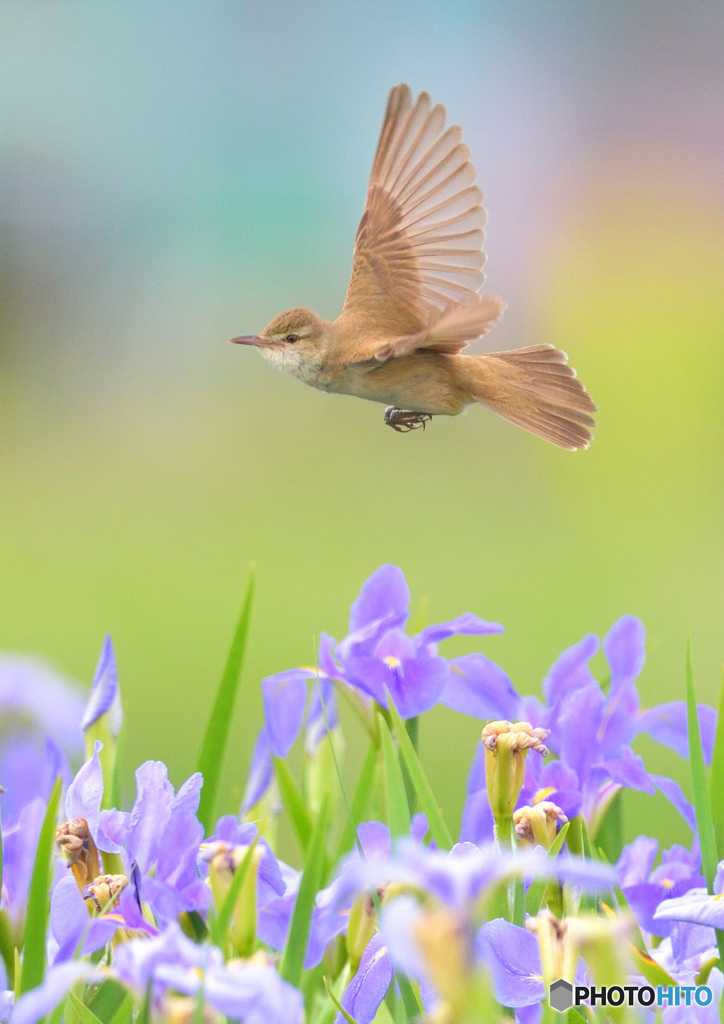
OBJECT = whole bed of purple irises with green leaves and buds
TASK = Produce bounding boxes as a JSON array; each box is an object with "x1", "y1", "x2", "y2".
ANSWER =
[{"x1": 0, "y1": 565, "x2": 724, "y2": 1024}]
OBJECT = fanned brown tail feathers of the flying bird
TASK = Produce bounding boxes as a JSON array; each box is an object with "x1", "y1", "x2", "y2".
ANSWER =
[{"x1": 457, "y1": 345, "x2": 596, "y2": 451}]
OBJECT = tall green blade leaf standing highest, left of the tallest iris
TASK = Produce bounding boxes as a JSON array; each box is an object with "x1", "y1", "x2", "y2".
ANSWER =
[{"x1": 197, "y1": 566, "x2": 254, "y2": 836}]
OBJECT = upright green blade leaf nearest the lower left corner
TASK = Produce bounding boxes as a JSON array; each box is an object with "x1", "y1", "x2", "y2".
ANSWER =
[{"x1": 19, "y1": 775, "x2": 62, "y2": 995}]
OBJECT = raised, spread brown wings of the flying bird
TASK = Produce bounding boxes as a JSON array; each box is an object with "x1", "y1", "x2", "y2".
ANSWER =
[{"x1": 341, "y1": 85, "x2": 503, "y2": 361}]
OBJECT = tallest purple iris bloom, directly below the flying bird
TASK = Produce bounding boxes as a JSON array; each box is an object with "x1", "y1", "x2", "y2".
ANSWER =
[{"x1": 262, "y1": 565, "x2": 512, "y2": 757}]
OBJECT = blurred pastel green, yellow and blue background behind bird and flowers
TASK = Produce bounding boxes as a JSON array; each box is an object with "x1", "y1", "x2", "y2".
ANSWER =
[{"x1": 0, "y1": 0, "x2": 724, "y2": 840}]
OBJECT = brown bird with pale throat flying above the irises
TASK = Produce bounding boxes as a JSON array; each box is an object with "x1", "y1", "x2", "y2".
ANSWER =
[{"x1": 231, "y1": 84, "x2": 596, "y2": 451}]
